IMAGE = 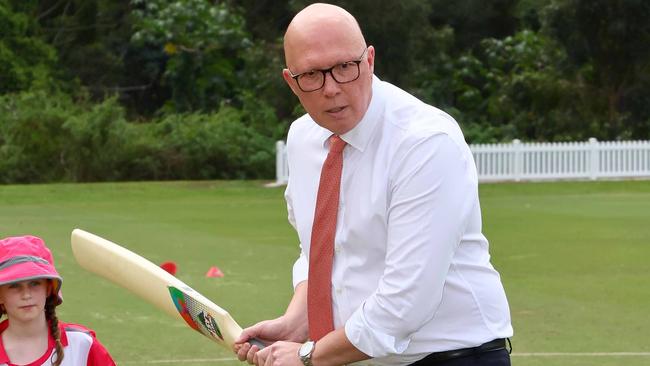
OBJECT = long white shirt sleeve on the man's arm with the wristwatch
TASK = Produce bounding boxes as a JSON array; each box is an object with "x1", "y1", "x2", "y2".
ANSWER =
[{"x1": 345, "y1": 134, "x2": 477, "y2": 357}]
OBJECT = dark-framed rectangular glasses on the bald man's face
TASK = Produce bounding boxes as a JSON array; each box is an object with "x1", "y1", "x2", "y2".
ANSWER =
[{"x1": 289, "y1": 48, "x2": 368, "y2": 93}]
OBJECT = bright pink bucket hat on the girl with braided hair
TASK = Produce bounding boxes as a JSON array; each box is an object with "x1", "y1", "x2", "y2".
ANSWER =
[{"x1": 0, "y1": 235, "x2": 63, "y2": 305}]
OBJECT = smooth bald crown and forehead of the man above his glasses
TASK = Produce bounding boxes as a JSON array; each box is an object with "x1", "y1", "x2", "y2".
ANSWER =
[{"x1": 284, "y1": 3, "x2": 366, "y2": 67}]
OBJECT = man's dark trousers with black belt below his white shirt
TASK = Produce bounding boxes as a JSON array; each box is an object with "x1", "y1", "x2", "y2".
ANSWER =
[{"x1": 409, "y1": 339, "x2": 512, "y2": 366}]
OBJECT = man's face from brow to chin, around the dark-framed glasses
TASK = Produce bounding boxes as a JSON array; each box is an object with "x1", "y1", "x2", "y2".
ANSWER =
[{"x1": 283, "y1": 43, "x2": 375, "y2": 135}]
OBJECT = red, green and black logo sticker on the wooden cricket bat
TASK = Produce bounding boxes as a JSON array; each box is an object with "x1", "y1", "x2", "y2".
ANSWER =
[{"x1": 168, "y1": 286, "x2": 223, "y2": 341}]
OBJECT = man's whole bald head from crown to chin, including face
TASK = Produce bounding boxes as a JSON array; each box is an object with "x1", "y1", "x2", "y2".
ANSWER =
[{"x1": 282, "y1": 3, "x2": 375, "y2": 135}]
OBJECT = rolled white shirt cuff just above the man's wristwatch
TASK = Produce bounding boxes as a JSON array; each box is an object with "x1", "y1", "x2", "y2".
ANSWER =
[{"x1": 345, "y1": 305, "x2": 411, "y2": 358}]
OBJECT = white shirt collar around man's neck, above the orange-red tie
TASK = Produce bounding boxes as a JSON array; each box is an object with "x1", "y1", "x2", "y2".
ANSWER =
[{"x1": 320, "y1": 75, "x2": 382, "y2": 152}]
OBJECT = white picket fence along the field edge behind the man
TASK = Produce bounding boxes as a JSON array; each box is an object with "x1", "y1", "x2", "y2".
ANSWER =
[{"x1": 276, "y1": 138, "x2": 650, "y2": 184}]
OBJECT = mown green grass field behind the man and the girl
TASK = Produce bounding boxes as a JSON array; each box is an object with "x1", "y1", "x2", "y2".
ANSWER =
[{"x1": 0, "y1": 181, "x2": 650, "y2": 366}]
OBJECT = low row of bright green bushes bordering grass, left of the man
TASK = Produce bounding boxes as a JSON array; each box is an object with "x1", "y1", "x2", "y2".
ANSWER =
[{"x1": 0, "y1": 92, "x2": 276, "y2": 183}]
